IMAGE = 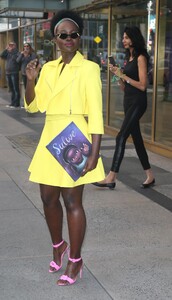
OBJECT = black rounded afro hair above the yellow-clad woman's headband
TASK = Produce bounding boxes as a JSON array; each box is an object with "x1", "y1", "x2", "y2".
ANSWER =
[{"x1": 50, "y1": 10, "x2": 84, "y2": 36}]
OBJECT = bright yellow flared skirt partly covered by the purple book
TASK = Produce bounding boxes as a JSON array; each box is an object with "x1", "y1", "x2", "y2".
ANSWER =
[{"x1": 29, "y1": 115, "x2": 105, "y2": 187}]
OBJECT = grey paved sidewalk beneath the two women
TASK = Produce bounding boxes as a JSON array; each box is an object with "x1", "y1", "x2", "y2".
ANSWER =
[{"x1": 0, "y1": 89, "x2": 172, "y2": 300}]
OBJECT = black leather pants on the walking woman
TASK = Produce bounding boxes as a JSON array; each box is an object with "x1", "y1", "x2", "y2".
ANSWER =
[{"x1": 111, "y1": 99, "x2": 150, "y2": 173}]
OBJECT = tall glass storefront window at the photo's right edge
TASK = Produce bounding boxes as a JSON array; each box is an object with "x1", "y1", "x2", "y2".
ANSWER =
[{"x1": 155, "y1": 0, "x2": 172, "y2": 147}]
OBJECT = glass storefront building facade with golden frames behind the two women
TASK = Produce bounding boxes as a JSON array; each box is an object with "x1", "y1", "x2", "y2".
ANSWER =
[{"x1": 0, "y1": 0, "x2": 172, "y2": 157}]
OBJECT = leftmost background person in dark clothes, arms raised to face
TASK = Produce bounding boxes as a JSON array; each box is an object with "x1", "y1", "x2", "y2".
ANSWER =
[{"x1": 0, "y1": 42, "x2": 20, "y2": 108}]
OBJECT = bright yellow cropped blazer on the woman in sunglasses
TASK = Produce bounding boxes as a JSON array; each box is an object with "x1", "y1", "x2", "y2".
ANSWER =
[{"x1": 25, "y1": 51, "x2": 104, "y2": 134}]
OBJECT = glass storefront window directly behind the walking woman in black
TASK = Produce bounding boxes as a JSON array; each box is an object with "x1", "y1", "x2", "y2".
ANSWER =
[{"x1": 109, "y1": 0, "x2": 155, "y2": 139}]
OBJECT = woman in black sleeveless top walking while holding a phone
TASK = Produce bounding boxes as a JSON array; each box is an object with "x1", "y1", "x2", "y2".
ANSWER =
[{"x1": 94, "y1": 27, "x2": 155, "y2": 189}]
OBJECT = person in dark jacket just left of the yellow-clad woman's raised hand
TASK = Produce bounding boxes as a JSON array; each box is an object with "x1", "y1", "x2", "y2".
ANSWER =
[{"x1": 16, "y1": 43, "x2": 37, "y2": 89}]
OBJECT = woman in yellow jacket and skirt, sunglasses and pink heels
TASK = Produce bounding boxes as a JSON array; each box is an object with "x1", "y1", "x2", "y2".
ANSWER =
[{"x1": 25, "y1": 10, "x2": 104, "y2": 285}]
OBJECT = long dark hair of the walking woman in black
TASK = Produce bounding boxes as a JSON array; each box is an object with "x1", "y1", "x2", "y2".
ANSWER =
[{"x1": 124, "y1": 26, "x2": 149, "y2": 64}]
